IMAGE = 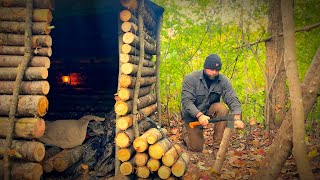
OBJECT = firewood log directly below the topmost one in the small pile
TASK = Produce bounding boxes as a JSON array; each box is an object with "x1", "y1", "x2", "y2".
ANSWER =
[{"x1": 149, "y1": 138, "x2": 171, "y2": 159}]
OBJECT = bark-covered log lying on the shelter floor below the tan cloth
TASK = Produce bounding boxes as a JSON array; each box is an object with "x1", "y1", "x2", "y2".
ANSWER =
[{"x1": 53, "y1": 144, "x2": 88, "y2": 172}]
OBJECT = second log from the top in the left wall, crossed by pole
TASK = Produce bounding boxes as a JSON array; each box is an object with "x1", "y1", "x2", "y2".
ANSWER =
[{"x1": 0, "y1": 7, "x2": 52, "y2": 23}]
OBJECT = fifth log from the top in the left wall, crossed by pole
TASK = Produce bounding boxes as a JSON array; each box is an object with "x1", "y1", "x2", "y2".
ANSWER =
[{"x1": 0, "y1": 46, "x2": 52, "y2": 57}]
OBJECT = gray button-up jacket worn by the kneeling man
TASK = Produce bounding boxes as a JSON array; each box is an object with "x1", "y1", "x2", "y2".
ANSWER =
[{"x1": 181, "y1": 70, "x2": 241, "y2": 122}]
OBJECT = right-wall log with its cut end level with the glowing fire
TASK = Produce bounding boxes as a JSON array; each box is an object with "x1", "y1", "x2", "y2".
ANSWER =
[{"x1": 119, "y1": 74, "x2": 156, "y2": 88}]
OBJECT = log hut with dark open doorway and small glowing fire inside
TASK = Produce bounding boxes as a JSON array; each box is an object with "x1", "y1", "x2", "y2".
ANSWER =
[{"x1": 0, "y1": 0, "x2": 172, "y2": 179}]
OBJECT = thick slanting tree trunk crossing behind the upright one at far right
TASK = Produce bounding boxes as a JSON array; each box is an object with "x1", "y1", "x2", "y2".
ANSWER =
[{"x1": 255, "y1": 48, "x2": 320, "y2": 180}]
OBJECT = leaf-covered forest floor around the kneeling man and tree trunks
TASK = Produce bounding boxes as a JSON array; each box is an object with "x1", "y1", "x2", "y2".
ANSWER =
[{"x1": 165, "y1": 121, "x2": 320, "y2": 180}]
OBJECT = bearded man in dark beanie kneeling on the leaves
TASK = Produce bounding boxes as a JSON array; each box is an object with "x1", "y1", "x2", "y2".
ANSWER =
[{"x1": 181, "y1": 54, "x2": 244, "y2": 152}]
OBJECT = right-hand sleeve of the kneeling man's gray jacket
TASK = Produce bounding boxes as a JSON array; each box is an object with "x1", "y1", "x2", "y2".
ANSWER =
[{"x1": 222, "y1": 78, "x2": 242, "y2": 114}]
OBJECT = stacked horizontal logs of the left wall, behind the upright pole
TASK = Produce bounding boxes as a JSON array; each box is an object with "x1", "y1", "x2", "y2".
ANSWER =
[{"x1": 0, "y1": 0, "x2": 54, "y2": 179}]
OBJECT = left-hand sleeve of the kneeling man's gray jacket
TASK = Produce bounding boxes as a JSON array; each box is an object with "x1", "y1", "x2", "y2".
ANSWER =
[{"x1": 181, "y1": 76, "x2": 200, "y2": 117}]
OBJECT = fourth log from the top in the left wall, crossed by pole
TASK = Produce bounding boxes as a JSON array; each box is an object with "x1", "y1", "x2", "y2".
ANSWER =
[{"x1": 0, "y1": 33, "x2": 52, "y2": 48}]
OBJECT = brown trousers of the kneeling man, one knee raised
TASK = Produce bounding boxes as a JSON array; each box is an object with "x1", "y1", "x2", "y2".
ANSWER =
[{"x1": 184, "y1": 103, "x2": 228, "y2": 152}]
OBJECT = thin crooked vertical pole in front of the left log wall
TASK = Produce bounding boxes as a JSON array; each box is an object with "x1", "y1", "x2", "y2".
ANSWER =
[{"x1": 3, "y1": 0, "x2": 33, "y2": 180}]
